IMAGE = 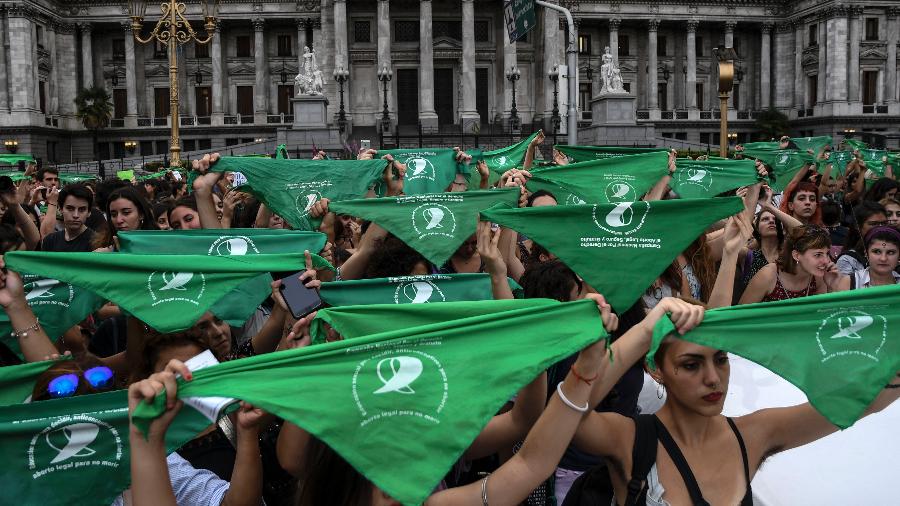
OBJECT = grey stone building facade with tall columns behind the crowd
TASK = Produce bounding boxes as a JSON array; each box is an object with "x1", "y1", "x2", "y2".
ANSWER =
[{"x1": 0, "y1": 0, "x2": 900, "y2": 162}]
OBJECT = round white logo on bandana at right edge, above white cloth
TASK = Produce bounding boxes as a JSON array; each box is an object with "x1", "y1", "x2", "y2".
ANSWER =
[{"x1": 816, "y1": 309, "x2": 887, "y2": 363}]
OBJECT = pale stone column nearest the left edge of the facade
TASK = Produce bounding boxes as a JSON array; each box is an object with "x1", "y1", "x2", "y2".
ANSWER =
[{"x1": 7, "y1": 6, "x2": 37, "y2": 112}]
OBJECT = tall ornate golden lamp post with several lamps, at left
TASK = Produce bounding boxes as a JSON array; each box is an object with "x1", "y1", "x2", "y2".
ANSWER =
[{"x1": 128, "y1": 0, "x2": 219, "y2": 166}]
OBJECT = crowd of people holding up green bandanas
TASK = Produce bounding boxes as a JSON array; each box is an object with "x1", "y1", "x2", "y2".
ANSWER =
[{"x1": 0, "y1": 131, "x2": 900, "y2": 506}]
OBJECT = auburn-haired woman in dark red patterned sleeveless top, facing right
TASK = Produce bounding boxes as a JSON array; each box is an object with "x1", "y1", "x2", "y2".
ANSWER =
[{"x1": 740, "y1": 225, "x2": 838, "y2": 304}]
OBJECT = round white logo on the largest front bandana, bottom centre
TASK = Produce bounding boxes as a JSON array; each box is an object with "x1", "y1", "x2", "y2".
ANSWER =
[{"x1": 348, "y1": 346, "x2": 449, "y2": 427}]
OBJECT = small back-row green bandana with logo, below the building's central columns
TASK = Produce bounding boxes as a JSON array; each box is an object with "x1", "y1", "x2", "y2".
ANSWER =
[{"x1": 378, "y1": 148, "x2": 459, "y2": 195}]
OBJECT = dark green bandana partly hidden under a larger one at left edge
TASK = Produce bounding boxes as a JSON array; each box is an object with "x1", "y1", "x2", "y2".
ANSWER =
[{"x1": 0, "y1": 276, "x2": 104, "y2": 358}]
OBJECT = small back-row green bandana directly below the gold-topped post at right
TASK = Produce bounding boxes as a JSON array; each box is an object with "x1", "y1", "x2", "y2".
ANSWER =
[{"x1": 669, "y1": 158, "x2": 759, "y2": 199}]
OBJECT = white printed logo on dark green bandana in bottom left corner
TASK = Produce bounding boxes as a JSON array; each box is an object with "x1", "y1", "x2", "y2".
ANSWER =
[{"x1": 28, "y1": 414, "x2": 124, "y2": 479}]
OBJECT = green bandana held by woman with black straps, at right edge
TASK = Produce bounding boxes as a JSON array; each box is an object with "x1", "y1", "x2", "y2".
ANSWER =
[{"x1": 647, "y1": 286, "x2": 900, "y2": 429}]
